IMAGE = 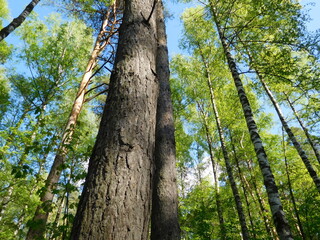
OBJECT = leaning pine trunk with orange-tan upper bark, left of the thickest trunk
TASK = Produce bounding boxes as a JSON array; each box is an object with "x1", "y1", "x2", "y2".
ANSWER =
[{"x1": 27, "y1": 6, "x2": 115, "y2": 240}]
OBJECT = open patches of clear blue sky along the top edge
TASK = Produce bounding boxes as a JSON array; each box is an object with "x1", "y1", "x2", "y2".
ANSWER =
[{"x1": 4, "y1": 0, "x2": 320, "y2": 56}]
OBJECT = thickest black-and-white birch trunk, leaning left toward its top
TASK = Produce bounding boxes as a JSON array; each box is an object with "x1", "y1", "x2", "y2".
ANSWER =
[{"x1": 211, "y1": 5, "x2": 293, "y2": 240}]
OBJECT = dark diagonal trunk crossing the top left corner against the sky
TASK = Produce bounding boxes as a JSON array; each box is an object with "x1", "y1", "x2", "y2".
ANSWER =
[{"x1": 0, "y1": 0, "x2": 40, "y2": 42}]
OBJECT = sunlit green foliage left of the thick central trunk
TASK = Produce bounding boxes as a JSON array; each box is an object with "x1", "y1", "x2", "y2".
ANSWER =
[{"x1": 0, "y1": 12, "x2": 98, "y2": 239}]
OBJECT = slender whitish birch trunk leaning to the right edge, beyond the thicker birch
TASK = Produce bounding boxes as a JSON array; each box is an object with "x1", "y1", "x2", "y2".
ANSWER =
[{"x1": 256, "y1": 70, "x2": 320, "y2": 192}]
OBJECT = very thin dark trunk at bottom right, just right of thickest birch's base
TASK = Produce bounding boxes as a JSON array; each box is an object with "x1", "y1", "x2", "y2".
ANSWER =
[{"x1": 282, "y1": 128, "x2": 306, "y2": 240}]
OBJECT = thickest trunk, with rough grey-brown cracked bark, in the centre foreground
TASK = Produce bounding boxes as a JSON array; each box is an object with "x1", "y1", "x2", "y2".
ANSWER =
[{"x1": 71, "y1": 0, "x2": 158, "y2": 240}]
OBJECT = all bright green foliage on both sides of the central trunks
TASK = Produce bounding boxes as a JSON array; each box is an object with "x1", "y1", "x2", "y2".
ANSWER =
[{"x1": 0, "y1": 0, "x2": 320, "y2": 240}]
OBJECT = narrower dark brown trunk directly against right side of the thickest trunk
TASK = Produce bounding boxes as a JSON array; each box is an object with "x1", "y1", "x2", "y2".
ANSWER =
[{"x1": 151, "y1": 1, "x2": 180, "y2": 240}]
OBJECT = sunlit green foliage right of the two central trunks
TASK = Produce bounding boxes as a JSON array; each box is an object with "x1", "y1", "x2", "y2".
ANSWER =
[{"x1": 171, "y1": 1, "x2": 319, "y2": 239}]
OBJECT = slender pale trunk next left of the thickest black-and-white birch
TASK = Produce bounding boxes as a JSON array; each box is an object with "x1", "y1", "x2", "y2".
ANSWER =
[{"x1": 201, "y1": 52, "x2": 250, "y2": 240}]
